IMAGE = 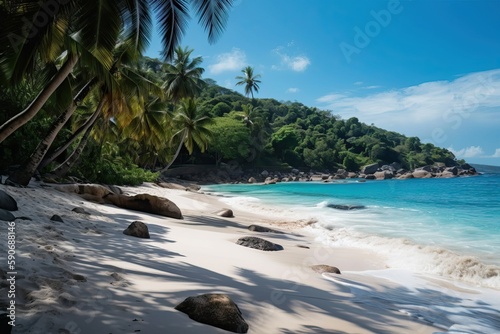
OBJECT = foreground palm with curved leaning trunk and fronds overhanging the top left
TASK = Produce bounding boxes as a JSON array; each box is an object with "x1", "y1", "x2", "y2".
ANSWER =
[{"x1": 0, "y1": 0, "x2": 233, "y2": 143}]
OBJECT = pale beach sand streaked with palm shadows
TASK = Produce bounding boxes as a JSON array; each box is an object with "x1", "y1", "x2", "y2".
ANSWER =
[{"x1": 0, "y1": 181, "x2": 473, "y2": 334}]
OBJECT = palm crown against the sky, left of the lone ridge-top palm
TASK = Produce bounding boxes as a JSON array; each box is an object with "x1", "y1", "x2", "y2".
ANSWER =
[{"x1": 163, "y1": 46, "x2": 205, "y2": 103}]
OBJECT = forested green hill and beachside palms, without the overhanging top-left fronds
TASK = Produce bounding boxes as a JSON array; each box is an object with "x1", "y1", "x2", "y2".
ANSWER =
[{"x1": 0, "y1": 53, "x2": 463, "y2": 184}]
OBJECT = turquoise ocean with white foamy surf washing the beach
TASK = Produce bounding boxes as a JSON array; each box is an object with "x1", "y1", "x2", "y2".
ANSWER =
[{"x1": 202, "y1": 169, "x2": 500, "y2": 333}]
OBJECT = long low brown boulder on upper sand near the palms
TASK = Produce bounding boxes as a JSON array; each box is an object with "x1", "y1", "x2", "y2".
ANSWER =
[{"x1": 105, "y1": 194, "x2": 183, "y2": 219}]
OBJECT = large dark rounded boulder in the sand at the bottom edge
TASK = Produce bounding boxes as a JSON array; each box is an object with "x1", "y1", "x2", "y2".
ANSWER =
[{"x1": 175, "y1": 294, "x2": 248, "y2": 333}]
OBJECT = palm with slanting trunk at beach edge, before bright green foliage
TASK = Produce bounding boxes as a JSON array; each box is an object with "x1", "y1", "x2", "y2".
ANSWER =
[{"x1": 161, "y1": 98, "x2": 212, "y2": 173}]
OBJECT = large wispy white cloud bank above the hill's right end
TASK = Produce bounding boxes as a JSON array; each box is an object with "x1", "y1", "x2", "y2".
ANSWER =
[{"x1": 316, "y1": 69, "x2": 500, "y2": 140}]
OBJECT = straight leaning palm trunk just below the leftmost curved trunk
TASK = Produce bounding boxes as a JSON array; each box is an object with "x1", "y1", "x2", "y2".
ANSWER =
[{"x1": 7, "y1": 75, "x2": 97, "y2": 186}]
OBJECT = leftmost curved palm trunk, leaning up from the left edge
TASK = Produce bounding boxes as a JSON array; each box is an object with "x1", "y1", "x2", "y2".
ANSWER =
[{"x1": 0, "y1": 55, "x2": 78, "y2": 143}]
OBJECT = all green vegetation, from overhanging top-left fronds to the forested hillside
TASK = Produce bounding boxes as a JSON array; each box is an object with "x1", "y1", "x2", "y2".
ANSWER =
[{"x1": 0, "y1": 0, "x2": 464, "y2": 185}]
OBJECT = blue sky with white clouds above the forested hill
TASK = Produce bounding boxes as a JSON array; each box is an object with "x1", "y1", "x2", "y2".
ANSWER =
[{"x1": 147, "y1": 0, "x2": 500, "y2": 166}]
